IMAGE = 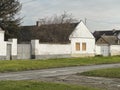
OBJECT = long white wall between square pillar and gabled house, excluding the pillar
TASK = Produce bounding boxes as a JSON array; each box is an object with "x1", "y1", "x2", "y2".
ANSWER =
[{"x1": 38, "y1": 44, "x2": 71, "y2": 55}]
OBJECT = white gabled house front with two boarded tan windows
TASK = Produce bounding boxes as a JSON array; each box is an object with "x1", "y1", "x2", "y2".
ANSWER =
[{"x1": 69, "y1": 21, "x2": 95, "y2": 57}]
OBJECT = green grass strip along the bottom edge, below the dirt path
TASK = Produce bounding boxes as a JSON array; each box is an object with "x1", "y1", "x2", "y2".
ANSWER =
[{"x1": 0, "y1": 81, "x2": 100, "y2": 90}]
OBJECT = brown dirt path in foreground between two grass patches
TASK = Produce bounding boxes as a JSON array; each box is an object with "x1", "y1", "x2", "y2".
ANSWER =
[{"x1": 36, "y1": 75, "x2": 120, "y2": 90}]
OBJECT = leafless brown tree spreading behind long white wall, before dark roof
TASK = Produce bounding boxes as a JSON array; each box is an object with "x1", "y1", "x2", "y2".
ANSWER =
[{"x1": 32, "y1": 12, "x2": 77, "y2": 43}]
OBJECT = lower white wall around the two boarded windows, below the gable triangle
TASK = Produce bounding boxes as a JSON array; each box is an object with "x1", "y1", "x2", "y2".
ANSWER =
[{"x1": 71, "y1": 38, "x2": 95, "y2": 55}]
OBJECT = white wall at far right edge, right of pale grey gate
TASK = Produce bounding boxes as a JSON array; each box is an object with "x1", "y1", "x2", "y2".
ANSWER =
[{"x1": 110, "y1": 45, "x2": 120, "y2": 56}]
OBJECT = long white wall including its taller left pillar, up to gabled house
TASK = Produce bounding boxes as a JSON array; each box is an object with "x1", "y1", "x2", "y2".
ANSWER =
[{"x1": 32, "y1": 40, "x2": 71, "y2": 55}]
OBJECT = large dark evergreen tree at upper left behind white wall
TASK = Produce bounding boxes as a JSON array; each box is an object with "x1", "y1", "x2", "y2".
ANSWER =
[{"x1": 0, "y1": 0, "x2": 21, "y2": 40}]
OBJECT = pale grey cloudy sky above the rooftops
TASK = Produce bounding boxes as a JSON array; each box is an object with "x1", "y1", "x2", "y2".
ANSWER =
[{"x1": 20, "y1": 0, "x2": 120, "y2": 31}]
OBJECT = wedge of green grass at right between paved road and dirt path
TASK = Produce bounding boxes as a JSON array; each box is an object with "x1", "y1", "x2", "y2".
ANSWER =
[{"x1": 79, "y1": 68, "x2": 120, "y2": 78}]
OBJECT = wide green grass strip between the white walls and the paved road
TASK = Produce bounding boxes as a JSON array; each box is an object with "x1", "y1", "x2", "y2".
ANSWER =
[{"x1": 0, "y1": 56, "x2": 120, "y2": 72}]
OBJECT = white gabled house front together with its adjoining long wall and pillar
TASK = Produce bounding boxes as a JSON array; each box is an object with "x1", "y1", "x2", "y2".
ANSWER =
[{"x1": 31, "y1": 21, "x2": 95, "y2": 59}]
